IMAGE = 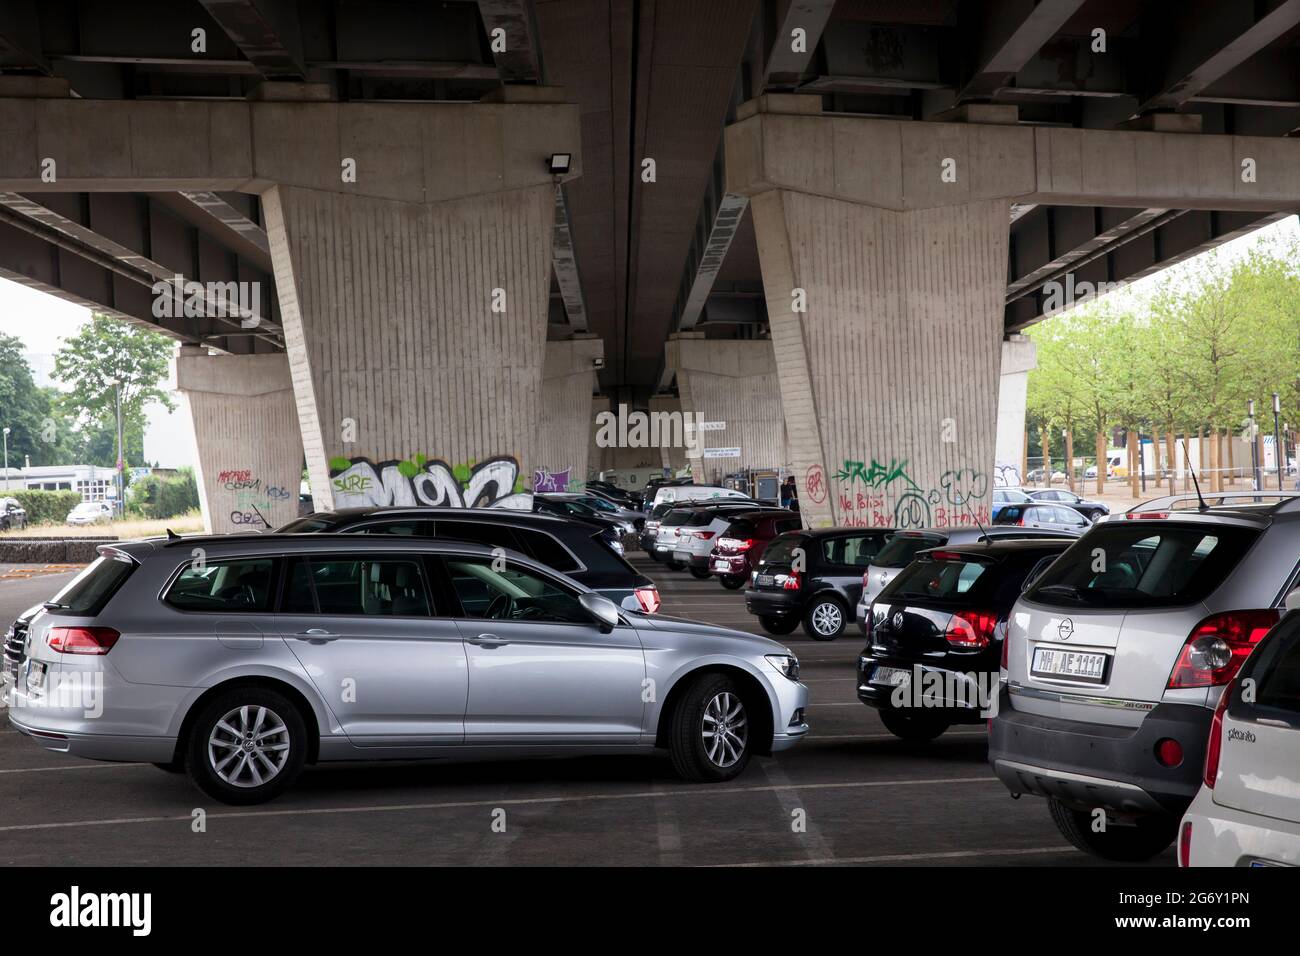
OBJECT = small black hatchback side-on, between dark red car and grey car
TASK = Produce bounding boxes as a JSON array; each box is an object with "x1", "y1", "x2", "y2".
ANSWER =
[{"x1": 745, "y1": 528, "x2": 893, "y2": 641}]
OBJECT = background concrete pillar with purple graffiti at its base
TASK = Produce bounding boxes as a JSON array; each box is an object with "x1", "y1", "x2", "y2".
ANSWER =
[{"x1": 529, "y1": 336, "x2": 605, "y2": 492}]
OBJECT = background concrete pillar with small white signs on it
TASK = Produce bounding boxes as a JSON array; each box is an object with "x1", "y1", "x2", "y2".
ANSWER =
[{"x1": 664, "y1": 332, "x2": 787, "y2": 484}]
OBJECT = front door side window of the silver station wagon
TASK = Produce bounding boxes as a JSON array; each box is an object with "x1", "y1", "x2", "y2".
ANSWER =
[{"x1": 443, "y1": 555, "x2": 592, "y2": 624}]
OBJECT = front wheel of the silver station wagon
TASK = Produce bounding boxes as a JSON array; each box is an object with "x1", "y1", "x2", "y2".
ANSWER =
[{"x1": 668, "y1": 674, "x2": 757, "y2": 783}]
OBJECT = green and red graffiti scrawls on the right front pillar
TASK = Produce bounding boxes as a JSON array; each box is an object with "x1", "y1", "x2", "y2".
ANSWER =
[{"x1": 835, "y1": 458, "x2": 991, "y2": 528}]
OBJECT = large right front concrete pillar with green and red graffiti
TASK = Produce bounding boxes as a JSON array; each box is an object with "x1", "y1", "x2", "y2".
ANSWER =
[{"x1": 727, "y1": 96, "x2": 1035, "y2": 528}]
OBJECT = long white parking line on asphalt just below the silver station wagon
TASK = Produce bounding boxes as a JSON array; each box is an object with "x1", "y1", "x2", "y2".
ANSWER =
[{"x1": 0, "y1": 777, "x2": 1001, "y2": 834}]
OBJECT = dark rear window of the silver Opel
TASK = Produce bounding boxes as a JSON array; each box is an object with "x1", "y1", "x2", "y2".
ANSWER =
[{"x1": 1026, "y1": 519, "x2": 1258, "y2": 607}]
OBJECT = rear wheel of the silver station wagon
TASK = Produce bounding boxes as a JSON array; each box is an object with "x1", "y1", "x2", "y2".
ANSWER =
[{"x1": 185, "y1": 687, "x2": 307, "y2": 805}]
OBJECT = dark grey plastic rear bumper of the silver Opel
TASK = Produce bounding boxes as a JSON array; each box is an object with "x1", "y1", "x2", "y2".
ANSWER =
[{"x1": 988, "y1": 689, "x2": 1213, "y2": 814}]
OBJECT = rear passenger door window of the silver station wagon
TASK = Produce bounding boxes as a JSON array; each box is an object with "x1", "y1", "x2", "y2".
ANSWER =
[{"x1": 281, "y1": 554, "x2": 430, "y2": 618}]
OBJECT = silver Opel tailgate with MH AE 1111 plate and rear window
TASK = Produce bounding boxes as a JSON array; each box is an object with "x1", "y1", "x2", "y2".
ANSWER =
[{"x1": 1008, "y1": 519, "x2": 1257, "y2": 727}]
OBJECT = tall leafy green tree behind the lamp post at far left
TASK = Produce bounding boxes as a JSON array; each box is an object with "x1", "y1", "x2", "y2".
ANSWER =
[{"x1": 55, "y1": 313, "x2": 176, "y2": 464}]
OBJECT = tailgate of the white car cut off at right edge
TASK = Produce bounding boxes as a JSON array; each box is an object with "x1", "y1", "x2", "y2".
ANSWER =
[{"x1": 1214, "y1": 611, "x2": 1300, "y2": 823}]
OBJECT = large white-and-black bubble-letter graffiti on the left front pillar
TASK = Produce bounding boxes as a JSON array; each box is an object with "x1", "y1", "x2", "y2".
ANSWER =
[{"x1": 329, "y1": 455, "x2": 533, "y2": 510}]
